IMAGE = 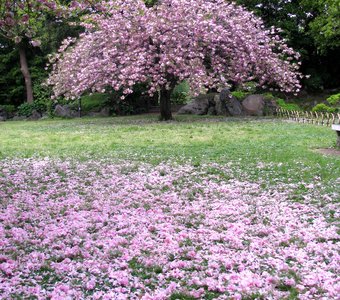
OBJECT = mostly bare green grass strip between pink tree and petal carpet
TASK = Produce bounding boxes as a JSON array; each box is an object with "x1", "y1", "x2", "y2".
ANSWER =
[{"x1": 0, "y1": 115, "x2": 340, "y2": 190}]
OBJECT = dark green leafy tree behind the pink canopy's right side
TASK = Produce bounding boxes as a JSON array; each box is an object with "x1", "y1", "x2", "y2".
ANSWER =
[{"x1": 237, "y1": 0, "x2": 340, "y2": 92}]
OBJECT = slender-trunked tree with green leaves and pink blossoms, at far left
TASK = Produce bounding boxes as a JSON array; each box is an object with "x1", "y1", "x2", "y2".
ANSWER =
[{"x1": 0, "y1": 0, "x2": 101, "y2": 103}]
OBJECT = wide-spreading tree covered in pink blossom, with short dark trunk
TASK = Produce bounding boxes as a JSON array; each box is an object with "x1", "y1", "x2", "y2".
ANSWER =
[{"x1": 49, "y1": 0, "x2": 300, "y2": 120}]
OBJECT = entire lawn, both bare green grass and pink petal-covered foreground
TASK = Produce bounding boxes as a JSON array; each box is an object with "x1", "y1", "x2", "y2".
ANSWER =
[{"x1": 0, "y1": 116, "x2": 340, "y2": 299}]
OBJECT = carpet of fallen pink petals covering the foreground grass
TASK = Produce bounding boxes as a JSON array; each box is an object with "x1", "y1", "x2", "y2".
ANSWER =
[{"x1": 0, "y1": 159, "x2": 340, "y2": 299}]
